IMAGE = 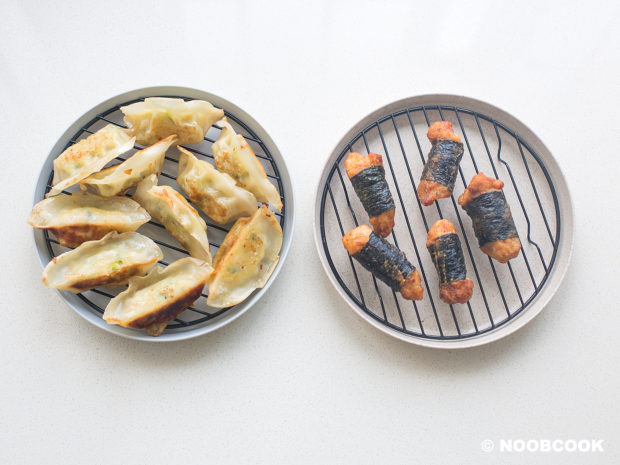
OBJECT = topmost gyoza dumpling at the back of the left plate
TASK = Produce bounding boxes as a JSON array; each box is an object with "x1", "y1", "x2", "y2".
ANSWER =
[{"x1": 121, "y1": 97, "x2": 224, "y2": 145}]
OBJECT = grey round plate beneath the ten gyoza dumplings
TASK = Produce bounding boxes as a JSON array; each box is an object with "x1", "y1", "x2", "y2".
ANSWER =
[{"x1": 34, "y1": 86, "x2": 295, "y2": 342}]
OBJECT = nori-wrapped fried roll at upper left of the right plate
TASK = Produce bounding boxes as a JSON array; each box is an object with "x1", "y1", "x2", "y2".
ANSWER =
[{"x1": 344, "y1": 152, "x2": 395, "y2": 237}]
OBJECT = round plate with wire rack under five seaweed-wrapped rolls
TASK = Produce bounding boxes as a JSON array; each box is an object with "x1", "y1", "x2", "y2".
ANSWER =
[{"x1": 314, "y1": 95, "x2": 573, "y2": 348}]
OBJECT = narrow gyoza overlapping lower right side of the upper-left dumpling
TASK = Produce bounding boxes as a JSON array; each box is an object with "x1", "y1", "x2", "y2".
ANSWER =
[{"x1": 80, "y1": 136, "x2": 176, "y2": 197}]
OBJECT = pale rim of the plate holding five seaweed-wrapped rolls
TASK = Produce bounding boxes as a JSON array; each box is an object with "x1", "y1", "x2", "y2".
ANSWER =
[{"x1": 312, "y1": 93, "x2": 575, "y2": 349}]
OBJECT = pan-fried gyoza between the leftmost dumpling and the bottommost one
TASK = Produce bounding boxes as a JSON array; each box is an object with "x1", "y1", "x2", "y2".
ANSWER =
[{"x1": 43, "y1": 231, "x2": 164, "y2": 294}]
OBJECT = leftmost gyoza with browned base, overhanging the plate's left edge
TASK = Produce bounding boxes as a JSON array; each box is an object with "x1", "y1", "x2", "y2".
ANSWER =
[{"x1": 28, "y1": 191, "x2": 151, "y2": 247}]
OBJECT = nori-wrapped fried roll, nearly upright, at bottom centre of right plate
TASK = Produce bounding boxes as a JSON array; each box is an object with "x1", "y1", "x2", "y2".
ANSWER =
[{"x1": 426, "y1": 220, "x2": 474, "y2": 304}]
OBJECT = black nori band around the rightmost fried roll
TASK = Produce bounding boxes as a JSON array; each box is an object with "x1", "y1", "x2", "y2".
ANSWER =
[{"x1": 463, "y1": 190, "x2": 519, "y2": 247}]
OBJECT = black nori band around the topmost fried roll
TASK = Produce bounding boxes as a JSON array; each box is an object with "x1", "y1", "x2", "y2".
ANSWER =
[{"x1": 420, "y1": 139, "x2": 463, "y2": 192}]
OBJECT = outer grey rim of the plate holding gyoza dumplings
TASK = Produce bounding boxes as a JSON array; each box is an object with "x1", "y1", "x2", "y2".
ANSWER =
[{"x1": 32, "y1": 85, "x2": 296, "y2": 342}]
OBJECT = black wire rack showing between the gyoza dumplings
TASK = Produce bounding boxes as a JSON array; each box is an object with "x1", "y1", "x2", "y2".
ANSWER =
[{"x1": 41, "y1": 95, "x2": 286, "y2": 332}]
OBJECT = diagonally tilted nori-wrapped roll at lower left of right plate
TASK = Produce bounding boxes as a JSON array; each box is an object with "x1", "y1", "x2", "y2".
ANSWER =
[{"x1": 342, "y1": 224, "x2": 423, "y2": 300}]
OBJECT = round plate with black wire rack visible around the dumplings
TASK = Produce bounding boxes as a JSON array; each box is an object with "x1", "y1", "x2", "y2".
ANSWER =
[{"x1": 34, "y1": 86, "x2": 295, "y2": 341}]
